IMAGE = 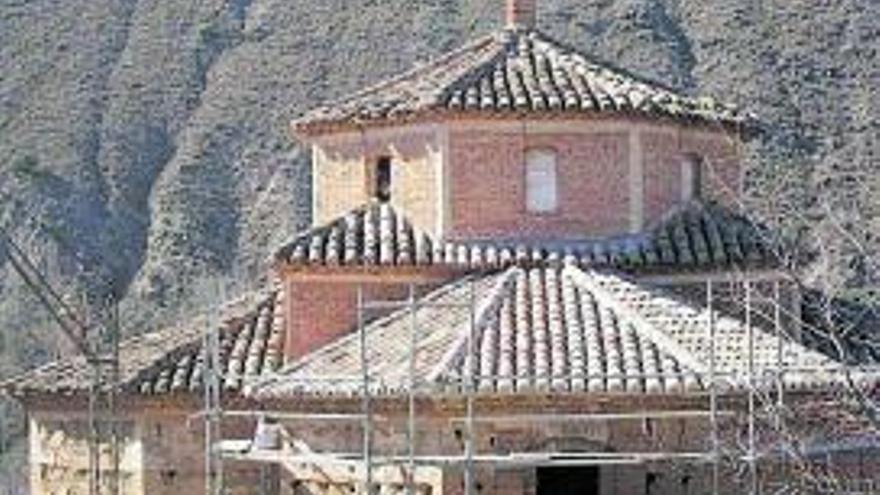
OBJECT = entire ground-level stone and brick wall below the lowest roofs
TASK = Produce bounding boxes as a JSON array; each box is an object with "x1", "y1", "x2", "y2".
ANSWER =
[{"x1": 29, "y1": 395, "x2": 878, "y2": 495}]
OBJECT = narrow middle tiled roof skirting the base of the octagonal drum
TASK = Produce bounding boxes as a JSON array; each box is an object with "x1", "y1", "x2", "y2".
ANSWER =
[{"x1": 276, "y1": 203, "x2": 772, "y2": 270}]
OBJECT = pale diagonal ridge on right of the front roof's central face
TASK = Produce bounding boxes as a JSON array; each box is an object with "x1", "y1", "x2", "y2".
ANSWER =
[{"x1": 563, "y1": 265, "x2": 706, "y2": 374}]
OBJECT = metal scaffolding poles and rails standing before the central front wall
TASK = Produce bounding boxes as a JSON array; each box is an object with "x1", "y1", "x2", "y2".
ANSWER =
[{"x1": 204, "y1": 272, "x2": 880, "y2": 495}]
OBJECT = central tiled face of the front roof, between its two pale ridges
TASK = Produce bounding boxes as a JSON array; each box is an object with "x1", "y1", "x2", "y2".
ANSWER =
[{"x1": 435, "y1": 268, "x2": 699, "y2": 393}]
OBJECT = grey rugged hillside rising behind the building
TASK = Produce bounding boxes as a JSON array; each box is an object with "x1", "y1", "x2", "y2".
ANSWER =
[{"x1": 0, "y1": 0, "x2": 880, "y2": 484}]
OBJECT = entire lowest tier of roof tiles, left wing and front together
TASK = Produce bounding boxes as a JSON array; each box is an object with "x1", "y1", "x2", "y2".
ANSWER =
[{"x1": 4, "y1": 265, "x2": 876, "y2": 397}]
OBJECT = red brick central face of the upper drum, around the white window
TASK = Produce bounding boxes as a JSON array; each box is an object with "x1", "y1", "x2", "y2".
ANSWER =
[{"x1": 448, "y1": 131, "x2": 629, "y2": 238}]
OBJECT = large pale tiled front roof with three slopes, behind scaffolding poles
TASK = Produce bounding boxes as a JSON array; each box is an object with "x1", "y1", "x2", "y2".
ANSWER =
[{"x1": 249, "y1": 266, "x2": 837, "y2": 397}]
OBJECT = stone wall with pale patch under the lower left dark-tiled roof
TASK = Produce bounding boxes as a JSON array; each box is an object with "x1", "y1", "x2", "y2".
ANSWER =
[{"x1": 29, "y1": 401, "x2": 261, "y2": 495}]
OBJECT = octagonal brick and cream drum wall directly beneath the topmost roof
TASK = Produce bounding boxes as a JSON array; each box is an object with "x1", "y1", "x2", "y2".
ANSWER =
[{"x1": 314, "y1": 120, "x2": 741, "y2": 244}]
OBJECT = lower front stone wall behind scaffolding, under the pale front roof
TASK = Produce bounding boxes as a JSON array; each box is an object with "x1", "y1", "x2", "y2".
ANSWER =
[{"x1": 282, "y1": 404, "x2": 720, "y2": 495}]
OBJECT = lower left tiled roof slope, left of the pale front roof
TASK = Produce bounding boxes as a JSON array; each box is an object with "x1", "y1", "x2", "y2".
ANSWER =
[{"x1": 4, "y1": 293, "x2": 284, "y2": 396}]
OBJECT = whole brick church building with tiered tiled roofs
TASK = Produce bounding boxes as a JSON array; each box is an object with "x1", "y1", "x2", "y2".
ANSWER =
[{"x1": 5, "y1": 0, "x2": 876, "y2": 495}]
